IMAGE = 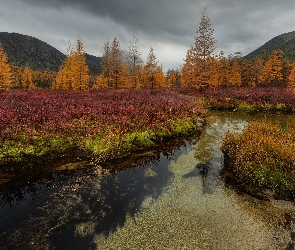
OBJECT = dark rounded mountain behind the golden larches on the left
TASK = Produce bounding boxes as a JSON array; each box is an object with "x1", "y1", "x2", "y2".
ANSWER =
[{"x1": 0, "y1": 32, "x2": 101, "y2": 75}]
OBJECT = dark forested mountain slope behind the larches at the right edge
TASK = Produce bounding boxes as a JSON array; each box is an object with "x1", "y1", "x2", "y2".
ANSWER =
[{"x1": 244, "y1": 31, "x2": 295, "y2": 60}]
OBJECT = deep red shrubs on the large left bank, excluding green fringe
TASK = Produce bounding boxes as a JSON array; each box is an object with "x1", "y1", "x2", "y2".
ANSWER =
[{"x1": 0, "y1": 89, "x2": 205, "y2": 142}]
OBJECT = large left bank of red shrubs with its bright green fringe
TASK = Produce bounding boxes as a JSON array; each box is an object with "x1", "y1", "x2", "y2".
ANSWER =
[{"x1": 0, "y1": 89, "x2": 206, "y2": 167}]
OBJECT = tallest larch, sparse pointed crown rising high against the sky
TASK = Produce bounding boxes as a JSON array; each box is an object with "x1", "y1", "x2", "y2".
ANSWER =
[{"x1": 195, "y1": 10, "x2": 216, "y2": 87}]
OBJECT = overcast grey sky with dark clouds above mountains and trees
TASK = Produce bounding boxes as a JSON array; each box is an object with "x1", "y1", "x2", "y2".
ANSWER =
[{"x1": 0, "y1": 0, "x2": 295, "y2": 70}]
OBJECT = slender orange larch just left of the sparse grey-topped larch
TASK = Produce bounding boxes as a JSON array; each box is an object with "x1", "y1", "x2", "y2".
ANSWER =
[{"x1": 109, "y1": 37, "x2": 123, "y2": 88}]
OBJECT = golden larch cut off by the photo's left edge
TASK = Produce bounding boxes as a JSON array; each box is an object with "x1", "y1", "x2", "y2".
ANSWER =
[{"x1": 0, "y1": 43, "x2": 12, "y2": 92}]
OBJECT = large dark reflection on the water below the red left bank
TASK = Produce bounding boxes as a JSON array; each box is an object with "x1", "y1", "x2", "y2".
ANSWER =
[{"x1": 0, "y1": 140, "x2": 198, "y2": 249}]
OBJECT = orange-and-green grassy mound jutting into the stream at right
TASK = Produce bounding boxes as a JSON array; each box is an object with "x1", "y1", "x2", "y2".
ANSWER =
[{"x1": 222, "y1": 120, "x2": 295, "y2": 200}]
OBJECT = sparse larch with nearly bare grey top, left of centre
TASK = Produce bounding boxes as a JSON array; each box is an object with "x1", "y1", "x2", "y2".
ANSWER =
[{"x1": 127, "y1": 35, "x2": 143, "y2": 88}]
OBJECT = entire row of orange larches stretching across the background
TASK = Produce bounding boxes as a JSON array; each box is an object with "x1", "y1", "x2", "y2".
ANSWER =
[{"x1": 0, "y1": 11, "x2": 295, "y2": 93}]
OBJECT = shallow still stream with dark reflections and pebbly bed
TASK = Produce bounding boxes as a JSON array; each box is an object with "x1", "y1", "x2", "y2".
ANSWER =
[{"x1": 0, "y1": 113, "x2": 295, "y2": 249}]
